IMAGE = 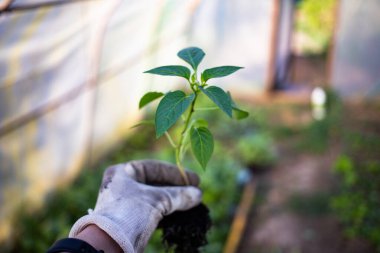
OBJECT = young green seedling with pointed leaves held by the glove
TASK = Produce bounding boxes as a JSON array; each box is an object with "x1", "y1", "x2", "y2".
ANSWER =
[{"x1": 139, "y1": 47, "x2": 248, "y2": 184}]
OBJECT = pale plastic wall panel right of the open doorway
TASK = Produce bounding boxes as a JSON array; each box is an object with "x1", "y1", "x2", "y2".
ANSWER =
[{"x1": 331, "y1": 0, "x2": 380, "y2": 99}]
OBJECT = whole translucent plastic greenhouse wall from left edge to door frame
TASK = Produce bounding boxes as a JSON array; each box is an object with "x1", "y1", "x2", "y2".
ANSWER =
[{"x1": 0, "y1": 0, "x2": 273, "y2": 241}]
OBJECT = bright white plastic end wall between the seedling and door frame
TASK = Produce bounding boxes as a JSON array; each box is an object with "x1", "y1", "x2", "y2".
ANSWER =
[{"x1": 189, "y1": 0, "x2": 274, "y2": 94}]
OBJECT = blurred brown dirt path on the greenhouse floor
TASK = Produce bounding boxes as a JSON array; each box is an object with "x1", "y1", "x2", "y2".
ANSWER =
[{"x1": 238, "y1": 146, "x2": 372, "y2": 253}]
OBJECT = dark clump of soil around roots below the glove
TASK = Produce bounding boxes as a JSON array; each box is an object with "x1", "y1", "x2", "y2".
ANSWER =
[{"x1": 158, "y1": 204, "x2": 211, "y2": 253}]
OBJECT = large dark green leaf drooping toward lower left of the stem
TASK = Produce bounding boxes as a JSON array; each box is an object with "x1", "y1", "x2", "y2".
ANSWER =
[{"x1": 155, "y1": 90, "x2": 195, "y2": 138}]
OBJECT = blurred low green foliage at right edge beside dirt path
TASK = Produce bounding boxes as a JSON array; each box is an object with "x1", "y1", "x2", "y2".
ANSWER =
[{"x1": 331, "y1": 155, "x2": 380, "y2": 252}]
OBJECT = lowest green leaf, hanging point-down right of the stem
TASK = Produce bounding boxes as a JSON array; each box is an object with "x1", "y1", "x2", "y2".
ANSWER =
[{"x1": 190, "y1": 127, "x2": 214, "y2": 169}]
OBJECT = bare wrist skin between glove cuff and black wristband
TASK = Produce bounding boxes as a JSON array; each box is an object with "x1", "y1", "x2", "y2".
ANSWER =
[{"x1": 66, "y1": 224, "x2": 123, "y2": 253}]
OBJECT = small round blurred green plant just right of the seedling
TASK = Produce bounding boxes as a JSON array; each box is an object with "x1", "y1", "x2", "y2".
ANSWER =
[{"x1": 236, "y1": 132, "x2": 277, "y2": 166}]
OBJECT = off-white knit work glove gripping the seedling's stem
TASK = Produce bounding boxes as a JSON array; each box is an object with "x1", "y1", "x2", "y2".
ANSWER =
[{"x1": 69, "y1": 160, "x2": 202, "y2": 253}]
